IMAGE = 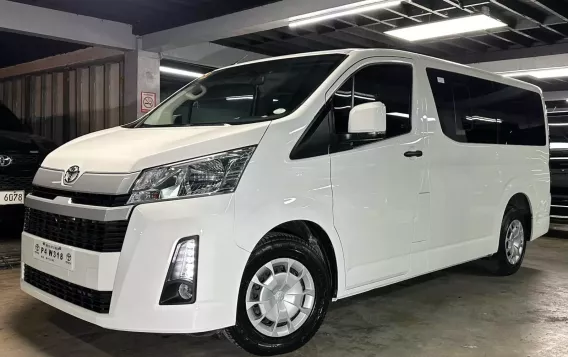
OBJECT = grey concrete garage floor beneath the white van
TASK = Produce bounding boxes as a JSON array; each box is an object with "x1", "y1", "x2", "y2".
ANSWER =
[{"x1": 0, "y1": 238, "x2": 568, "y2": 357}]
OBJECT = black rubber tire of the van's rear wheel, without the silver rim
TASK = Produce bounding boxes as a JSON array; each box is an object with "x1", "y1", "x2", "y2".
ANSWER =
[{"x1": 491, "y1": 206, "x2": 531, "y2": 276}]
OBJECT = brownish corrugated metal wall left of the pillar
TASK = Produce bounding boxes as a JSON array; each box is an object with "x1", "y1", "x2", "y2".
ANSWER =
[{"x1": 0, "y1": 61, "x2": 124, "y2": 144}]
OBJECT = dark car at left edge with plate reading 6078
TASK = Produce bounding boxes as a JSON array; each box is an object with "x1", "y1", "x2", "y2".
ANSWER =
[{"x1": 0, "y1": 102, "x2": 57, "y2": 232}]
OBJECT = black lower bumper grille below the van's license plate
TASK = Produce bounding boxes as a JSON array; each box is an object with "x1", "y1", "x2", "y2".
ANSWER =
[{"x1": 24, "y1": 265, "x2": 112, "y2": 314}]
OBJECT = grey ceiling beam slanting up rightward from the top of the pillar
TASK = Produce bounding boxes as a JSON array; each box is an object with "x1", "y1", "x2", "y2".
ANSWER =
[{"x1": 142, "y1": 0, "x2": 390, "y2": 52}]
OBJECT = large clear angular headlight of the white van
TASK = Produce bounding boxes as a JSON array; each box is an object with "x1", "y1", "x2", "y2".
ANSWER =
[{"x1": 127, "y1": 146, "x2": 255, "y2": 204}]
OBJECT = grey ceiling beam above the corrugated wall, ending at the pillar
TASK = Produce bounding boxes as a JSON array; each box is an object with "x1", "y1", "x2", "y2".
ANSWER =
[{"x1": 0, "y1": 0, "x2": 136, "y2": 50}]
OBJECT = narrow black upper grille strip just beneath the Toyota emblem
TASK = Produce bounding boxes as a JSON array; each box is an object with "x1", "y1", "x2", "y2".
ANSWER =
[{"x1": 32, "y1": 186, "x2": 130, "y2": 207}]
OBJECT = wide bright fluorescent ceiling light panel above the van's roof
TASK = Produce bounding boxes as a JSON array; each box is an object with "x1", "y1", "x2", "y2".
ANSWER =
[{"x1": 385, "y1": 15, "x2": 507, "y2": 41}]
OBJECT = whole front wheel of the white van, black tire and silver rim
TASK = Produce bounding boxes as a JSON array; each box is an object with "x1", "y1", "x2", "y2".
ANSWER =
[{"x1": 224, "y1": 233, "x2": 332, "y2": 356}]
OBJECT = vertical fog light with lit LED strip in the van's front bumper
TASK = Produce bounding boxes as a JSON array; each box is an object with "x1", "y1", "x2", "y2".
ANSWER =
[{"x1": 160, "y1": 236, "x2": 198, "y2": 305}]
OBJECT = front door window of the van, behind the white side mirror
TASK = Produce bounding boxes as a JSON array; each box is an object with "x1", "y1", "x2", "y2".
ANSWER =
[{"x1": 333, "y1": 63, "x2": 412, "y2": 138}]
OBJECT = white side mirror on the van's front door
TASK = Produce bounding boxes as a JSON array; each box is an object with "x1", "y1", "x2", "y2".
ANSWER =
[{"x1": 347, "y1": 102, "x2": 387, "y2": 135}]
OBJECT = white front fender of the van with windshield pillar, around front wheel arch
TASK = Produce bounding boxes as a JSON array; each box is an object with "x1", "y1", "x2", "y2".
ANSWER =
[{"x1": 234, "y1": 58, "x2": 352, "y2": 296}]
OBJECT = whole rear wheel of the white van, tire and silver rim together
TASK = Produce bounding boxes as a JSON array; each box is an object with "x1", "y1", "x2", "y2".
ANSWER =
[{"x1": 492, "y1": 206, "x2": 530, "y2": 276}]
